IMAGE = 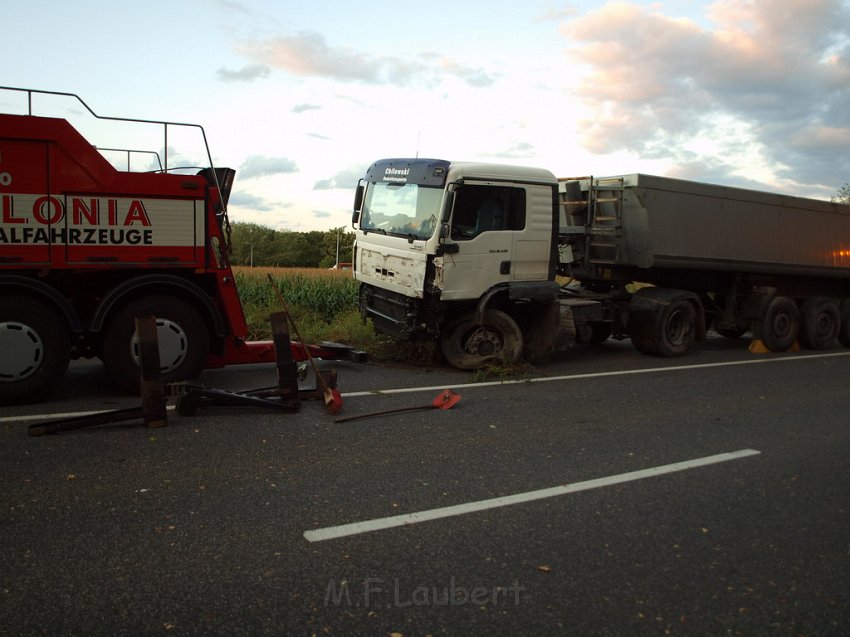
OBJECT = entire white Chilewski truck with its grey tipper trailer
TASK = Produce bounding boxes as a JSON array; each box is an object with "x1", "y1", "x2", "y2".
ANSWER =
[{"x1": 352, "y1": 158, "x2": 850, "y2": 369}]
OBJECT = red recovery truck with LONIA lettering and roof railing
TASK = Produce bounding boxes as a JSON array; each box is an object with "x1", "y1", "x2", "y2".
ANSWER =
[{"x1": 0, "y1": 87, "x2": 352, "y2": 404}]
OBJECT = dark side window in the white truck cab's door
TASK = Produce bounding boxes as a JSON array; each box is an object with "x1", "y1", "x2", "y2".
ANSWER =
[{"x1": 451, "y1": 185, "x2": 525, "y2": 241}]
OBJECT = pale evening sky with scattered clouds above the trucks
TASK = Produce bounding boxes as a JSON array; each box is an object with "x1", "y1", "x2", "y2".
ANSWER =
[{"x1": 0, "y1": 0, "x2": 850, "y2": 231}]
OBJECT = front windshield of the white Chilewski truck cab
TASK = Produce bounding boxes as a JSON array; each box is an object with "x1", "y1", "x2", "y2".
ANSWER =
[{"x1": 360, "y1": 181, "x2": 443, "y2": 240}]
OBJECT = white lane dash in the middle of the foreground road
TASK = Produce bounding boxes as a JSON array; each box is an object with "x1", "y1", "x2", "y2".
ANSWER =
[{"x1": 304, "y1": 449, "x2": 761, "y2": 542}]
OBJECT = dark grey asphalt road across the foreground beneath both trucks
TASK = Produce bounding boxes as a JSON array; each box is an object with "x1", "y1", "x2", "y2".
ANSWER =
[{"x1": 0, "y1": 339, "x2": 850, "y2": 637}]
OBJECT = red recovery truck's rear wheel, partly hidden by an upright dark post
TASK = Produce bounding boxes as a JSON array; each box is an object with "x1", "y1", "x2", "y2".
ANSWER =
[{"x1": 101, "y1": 295, "x2": 210, "y2": 393}]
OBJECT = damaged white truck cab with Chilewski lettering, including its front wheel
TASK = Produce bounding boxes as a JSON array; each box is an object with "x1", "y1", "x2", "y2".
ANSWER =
[{"x1": 352, "y1": 159, "x2": 559, "y2": 369}]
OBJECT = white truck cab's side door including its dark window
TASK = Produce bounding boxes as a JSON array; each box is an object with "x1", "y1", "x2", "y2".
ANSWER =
[{"x1": 442, "y1": 181, "x2": 526, "y2": 301}]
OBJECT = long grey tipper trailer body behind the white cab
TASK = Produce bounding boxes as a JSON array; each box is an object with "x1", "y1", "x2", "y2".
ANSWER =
[{"x1": 559, "y1": 174, "x2": 850, "y2": 278}]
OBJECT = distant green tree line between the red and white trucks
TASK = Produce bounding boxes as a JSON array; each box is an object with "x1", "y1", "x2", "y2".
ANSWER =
[{"x1": 225, "y1": 222, "x2": 354, "y2": 268}]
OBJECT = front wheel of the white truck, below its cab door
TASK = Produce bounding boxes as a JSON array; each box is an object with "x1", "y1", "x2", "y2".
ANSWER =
[{"x1": 440, "y1": 310, "x2": 522, "y2": 369}]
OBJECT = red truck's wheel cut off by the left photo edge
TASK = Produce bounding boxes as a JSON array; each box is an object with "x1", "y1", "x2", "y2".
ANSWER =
[{"x1": 0, "y1": 296, "x2": 71, "y2": 405}]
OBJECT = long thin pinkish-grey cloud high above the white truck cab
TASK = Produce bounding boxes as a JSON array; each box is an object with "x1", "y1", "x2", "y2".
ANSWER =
[{"x1": 243, "y1": 31, "x2": 493, "y2": 87}]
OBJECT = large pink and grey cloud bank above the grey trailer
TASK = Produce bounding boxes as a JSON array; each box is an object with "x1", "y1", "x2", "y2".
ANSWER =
[{"x1": 561, "y1": 0, "x2": 850, "y2": 191}]
